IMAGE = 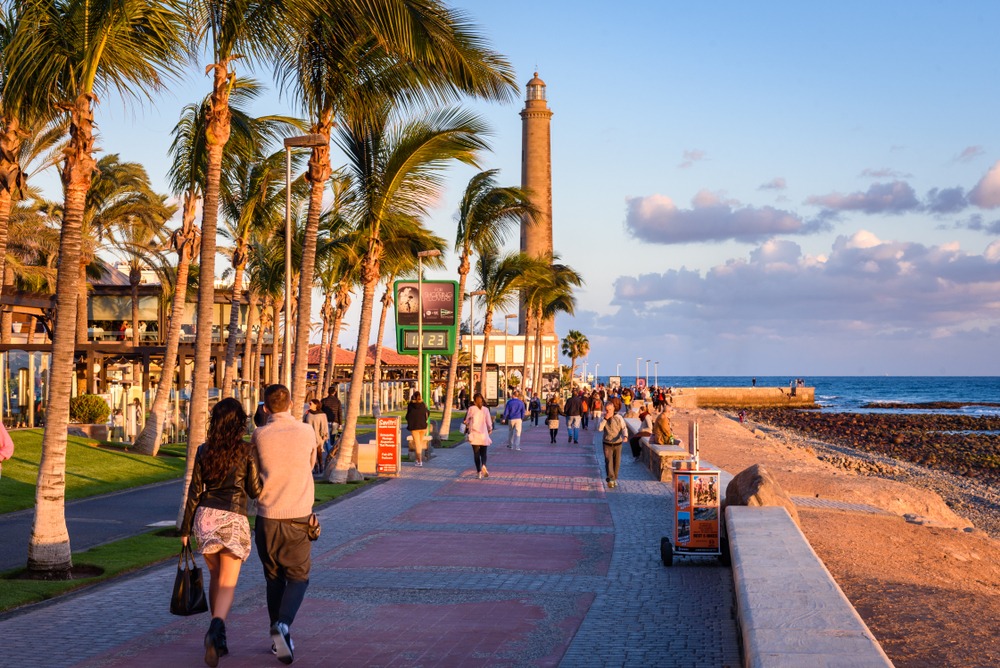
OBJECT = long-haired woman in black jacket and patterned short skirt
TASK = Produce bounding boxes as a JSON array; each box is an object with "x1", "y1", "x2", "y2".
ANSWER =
[{"x1": 181, "y1": 397, "x2": 261, "y2": 666}]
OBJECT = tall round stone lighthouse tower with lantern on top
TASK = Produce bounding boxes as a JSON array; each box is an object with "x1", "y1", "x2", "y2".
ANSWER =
[{"x1": 518, "y1": 72, "x2": 555, "y2": 337}]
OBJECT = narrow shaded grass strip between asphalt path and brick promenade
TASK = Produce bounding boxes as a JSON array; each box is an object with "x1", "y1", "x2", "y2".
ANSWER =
[{"x1": 0, "y1": 480, "x2": 374, "y2": 612}]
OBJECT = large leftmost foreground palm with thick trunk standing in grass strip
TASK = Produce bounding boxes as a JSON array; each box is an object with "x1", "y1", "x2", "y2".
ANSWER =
[{"x1": 4, "y1": 0, "x2": 181, "y2": 572}]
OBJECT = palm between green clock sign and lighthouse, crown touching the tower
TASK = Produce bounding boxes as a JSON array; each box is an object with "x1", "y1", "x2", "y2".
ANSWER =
[{"x1": 440, "y1": 170, "x2": 535, "y2": 439}]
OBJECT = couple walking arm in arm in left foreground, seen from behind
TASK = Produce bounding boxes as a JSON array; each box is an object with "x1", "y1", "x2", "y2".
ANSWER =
[{"x1": 181, "y1": 385, "x2": 316, "y2": 666}]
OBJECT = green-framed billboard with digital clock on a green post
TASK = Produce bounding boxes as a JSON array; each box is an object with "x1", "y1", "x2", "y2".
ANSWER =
[{"x1": 393, "y1": 280, "x2": 458, "y2": 401}]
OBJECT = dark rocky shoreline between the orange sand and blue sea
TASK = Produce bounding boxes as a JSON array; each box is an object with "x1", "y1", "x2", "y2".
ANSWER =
[{"x1": 747, "y1": 409, "x2": 1000, "y2": 539}]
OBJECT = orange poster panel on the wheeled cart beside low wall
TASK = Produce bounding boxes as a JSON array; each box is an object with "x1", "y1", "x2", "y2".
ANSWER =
[{"x1": 673, "y1": 471, "x2": 719, "y2": 554}]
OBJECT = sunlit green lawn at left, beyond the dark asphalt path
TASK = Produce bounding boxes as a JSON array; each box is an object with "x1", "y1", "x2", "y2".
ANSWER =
[{"x1": 0, "y1": 429, "x2": 184, "y2": 513}]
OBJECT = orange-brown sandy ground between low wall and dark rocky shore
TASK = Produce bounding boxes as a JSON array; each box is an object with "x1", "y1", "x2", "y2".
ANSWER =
[{"x1": 674, "y1": 409, "x2": 1000, "y2": 667}]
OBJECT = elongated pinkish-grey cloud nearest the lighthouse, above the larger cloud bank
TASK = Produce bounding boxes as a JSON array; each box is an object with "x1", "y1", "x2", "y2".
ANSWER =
[{"x1": 625, "y1": 191, "x2": 822, "y2": 244}]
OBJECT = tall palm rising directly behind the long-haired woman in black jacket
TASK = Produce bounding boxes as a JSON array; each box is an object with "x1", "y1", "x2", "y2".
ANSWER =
[{"x1": 187, "y1": 0, "x2": 299, "y2": 469}]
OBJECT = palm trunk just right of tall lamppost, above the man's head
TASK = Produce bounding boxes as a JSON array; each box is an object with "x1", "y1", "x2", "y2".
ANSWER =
[{"x1": 292, "y1": 122, "x2": 333, "y2": 406}]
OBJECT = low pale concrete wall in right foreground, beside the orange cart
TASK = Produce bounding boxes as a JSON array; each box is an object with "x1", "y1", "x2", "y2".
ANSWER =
[{"x1": 726, "y1": 506, "x2": 892, "y2": 668}]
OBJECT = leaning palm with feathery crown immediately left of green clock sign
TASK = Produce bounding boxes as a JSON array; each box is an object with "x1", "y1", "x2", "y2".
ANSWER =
[{"x1": 329, "y1": 102, "x2": 487, "y2": 482}]
